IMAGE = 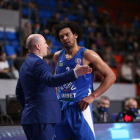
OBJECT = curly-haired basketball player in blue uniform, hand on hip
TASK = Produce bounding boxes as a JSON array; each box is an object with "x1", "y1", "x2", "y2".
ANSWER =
[{"x1": 53, "y1": 22, "x2": 116, "y2": 140}]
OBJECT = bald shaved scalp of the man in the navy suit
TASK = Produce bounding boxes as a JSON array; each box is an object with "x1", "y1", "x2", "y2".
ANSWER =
[{"x1": 26, "y1": 34, "x2": 43, "y2": 51}]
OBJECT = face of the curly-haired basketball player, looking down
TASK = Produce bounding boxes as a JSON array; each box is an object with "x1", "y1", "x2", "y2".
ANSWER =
[{"x1": 59, "y1": 28, "x2": 78, "y2": 49}]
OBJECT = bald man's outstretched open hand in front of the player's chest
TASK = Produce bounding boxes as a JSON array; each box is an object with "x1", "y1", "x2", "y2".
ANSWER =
[{"x1": 74, "y1": 60, "x2": 92, "y2": 76}]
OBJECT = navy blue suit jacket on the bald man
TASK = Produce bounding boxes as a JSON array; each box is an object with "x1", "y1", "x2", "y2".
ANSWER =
[{"x1": 16, "y1": 53, "x2": 76, "y2": 124}]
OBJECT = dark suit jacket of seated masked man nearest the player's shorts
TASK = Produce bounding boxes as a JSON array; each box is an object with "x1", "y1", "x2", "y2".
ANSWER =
[{"x1": 93, "y1": 108, "x2": 114, "y2": 122}]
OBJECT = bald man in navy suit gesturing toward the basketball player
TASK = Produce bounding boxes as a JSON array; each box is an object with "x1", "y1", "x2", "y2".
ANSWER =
[{"x1": 16, "y1": 34, "x2": 92, "y2": 140}]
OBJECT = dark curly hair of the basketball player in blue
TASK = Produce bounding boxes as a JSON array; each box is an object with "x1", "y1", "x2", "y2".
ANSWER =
[{"x1": 53, "y1": 21, "x2": 82, "y2": 42}]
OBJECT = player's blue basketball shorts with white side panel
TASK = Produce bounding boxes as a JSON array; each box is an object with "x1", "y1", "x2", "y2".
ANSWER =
[{"x1": 53, "y1": 105, "x2": 95, "y2": 140}]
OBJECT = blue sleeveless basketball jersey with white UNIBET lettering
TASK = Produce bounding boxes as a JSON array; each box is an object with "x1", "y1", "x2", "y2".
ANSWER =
[{"x1": 57, "y1": 47, "x2": 93, "y2": 102}]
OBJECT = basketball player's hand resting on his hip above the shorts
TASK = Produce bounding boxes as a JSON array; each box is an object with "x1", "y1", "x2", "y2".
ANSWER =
[{"x1": 78, "y1": 95, "x2": 95, "y2": 111}]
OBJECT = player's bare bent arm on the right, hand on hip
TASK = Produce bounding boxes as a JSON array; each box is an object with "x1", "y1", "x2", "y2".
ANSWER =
[{"x1": 79, "y1": 49, "x2": 116, "y2": 110}]
